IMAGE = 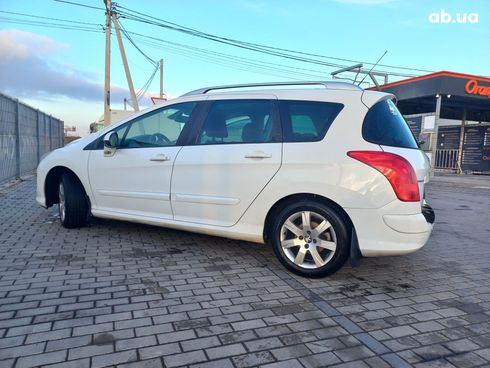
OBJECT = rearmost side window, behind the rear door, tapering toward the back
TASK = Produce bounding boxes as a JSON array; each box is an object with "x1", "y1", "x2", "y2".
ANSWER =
[{"x1": 280, "y1": 101, "x2": 344, "y2": 142}]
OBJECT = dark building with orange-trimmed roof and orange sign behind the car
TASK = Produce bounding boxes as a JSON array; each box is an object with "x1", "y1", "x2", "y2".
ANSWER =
[{"x1": 373, "y1": 71, "x2": 490, "y2": 173}]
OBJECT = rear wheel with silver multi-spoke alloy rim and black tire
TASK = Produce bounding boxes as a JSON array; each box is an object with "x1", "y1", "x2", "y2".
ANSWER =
[{"x1": 271, "y1": 201, "x2": 350, "y2": 277}]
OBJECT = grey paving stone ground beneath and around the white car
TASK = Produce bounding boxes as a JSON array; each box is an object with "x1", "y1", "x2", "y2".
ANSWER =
[{"x1": 0, "y1": 178, "x2": 490, "y2": 368}]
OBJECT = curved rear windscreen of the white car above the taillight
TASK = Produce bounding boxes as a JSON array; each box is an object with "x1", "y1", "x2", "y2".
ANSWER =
[{"x1": 362, "y1": 100, "x2": 418, "y2": 148}]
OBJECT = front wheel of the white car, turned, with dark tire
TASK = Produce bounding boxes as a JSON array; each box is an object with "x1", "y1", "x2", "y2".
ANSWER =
[{"x1": 58, "y1": 174, "x2": 88, "y2": 229}]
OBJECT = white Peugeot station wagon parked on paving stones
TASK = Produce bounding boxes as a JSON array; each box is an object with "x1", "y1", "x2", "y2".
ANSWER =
[{"x1": 37, "y1": 82, "x2": 434, "y2": 277}]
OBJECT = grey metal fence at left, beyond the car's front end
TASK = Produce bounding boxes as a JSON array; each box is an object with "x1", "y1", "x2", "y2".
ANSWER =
[{"x1": 0, "y1": 93, "x2": 64, "y2": 183}]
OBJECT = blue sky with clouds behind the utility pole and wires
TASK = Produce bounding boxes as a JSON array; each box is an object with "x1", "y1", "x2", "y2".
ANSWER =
[{"x1": 0, "y1": 0, "x2": 490, "y2": 134}]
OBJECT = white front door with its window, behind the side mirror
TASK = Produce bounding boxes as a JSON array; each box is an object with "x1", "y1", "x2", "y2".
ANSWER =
[{"x1": 88, "y1": 102, "x2": 196, "y2": 219}]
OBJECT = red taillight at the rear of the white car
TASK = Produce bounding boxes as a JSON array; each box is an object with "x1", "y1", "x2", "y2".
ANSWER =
[{"x1": 347, "y1": 151, "x2": 420, "y2": 202}]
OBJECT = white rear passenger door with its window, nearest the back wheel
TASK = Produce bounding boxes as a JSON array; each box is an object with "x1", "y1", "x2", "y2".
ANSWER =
[{"x1": 172, "y1": 95, "x2": 282, "y2": 226}]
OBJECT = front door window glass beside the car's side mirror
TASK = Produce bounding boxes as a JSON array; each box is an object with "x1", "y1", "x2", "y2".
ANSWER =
[{"x1": 118, "y1": 102, "x2": 196, "y2": 148}]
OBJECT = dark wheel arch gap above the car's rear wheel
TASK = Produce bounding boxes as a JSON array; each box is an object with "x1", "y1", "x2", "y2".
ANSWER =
[{"x1": 263, "y1": 193, "x2": 354, "y2": 242}]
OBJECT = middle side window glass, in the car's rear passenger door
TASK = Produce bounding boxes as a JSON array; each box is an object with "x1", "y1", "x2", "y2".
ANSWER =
[{"x1": 197, "y1": 100, "x2": 273, "y2": 144}]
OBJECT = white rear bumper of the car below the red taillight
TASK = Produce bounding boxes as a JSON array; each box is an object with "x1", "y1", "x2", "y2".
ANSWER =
[{"x1": 348, "y1": 204, "x2": 434, "y2": 257}]
